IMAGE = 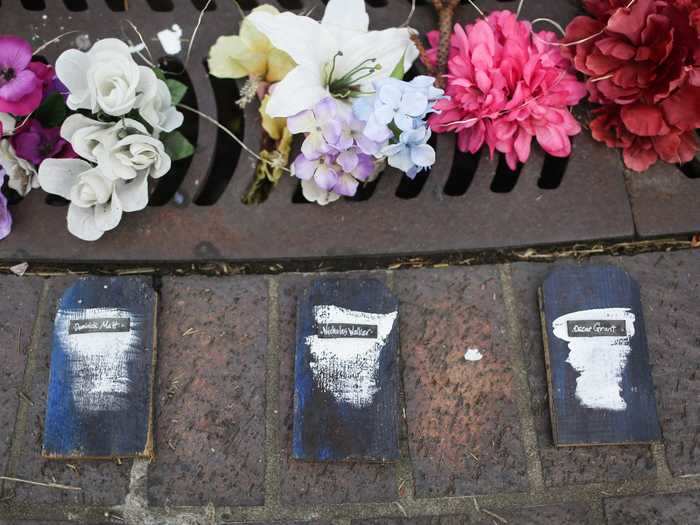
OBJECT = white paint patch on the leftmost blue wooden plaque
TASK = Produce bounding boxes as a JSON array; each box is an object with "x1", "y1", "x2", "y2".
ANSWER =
[{"x1": 55, "y1": 308, "x2": 143, "y2": 412}]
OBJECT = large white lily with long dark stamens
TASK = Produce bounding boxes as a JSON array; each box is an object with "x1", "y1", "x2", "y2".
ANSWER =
[{"x1": 248, "y1": 0, "x2": 418, "y2": 117}]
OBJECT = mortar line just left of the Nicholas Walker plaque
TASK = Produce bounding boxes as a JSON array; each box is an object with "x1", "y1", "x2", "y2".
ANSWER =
[{"x1": 265, "y1": 277, "x2": 281, "y2": 508}]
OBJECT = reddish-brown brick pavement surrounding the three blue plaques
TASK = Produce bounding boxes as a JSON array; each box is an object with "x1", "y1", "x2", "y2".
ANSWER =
[{"x1": 0, "y1": 250, "x2": 700, "y2": 525}]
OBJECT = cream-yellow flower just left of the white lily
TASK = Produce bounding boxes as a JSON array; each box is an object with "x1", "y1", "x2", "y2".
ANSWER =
[{"x1": 209, "y1": 5, "x2": 296, "y2": 82}]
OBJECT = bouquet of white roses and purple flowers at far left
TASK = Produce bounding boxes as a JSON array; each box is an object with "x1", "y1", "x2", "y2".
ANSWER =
[{"x1": 0, "y1": 36, "x2": 194, "y2": 241}]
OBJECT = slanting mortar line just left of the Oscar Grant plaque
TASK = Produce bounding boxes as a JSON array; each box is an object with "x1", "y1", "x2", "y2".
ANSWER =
[{"x1": 499, "y1": 264, "x2": 544, "y2": 492}]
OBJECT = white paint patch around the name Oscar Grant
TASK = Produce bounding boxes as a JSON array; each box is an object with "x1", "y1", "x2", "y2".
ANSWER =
[{"x1": 552, "y1": 308, "x2": 635, "y2": 411}]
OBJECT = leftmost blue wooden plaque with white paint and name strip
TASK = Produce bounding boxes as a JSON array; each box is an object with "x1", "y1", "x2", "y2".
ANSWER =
[{"x1": 43, "y1": 277, "x2": 157, "y2": 459}]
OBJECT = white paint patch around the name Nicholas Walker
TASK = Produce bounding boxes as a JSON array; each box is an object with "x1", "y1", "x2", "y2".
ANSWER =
[{"x1": 306, "y1": 305, "x2": 398, "y2": 408}]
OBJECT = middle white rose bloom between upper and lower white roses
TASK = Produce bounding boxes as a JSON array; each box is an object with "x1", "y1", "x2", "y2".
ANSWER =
[{"x1": 61, "y1": 115, "x2": 172, "y2": 180}]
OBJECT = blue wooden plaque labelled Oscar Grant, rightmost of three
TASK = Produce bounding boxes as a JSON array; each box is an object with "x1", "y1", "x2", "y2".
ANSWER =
[{"x1": 540, "y1": 265, "x2": 660, "y2": 446}]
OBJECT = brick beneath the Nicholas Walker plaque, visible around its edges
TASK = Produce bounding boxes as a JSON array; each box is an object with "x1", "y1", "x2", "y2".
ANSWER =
[{"x1": 279, "y1": 273, "x2": 397, "y2": 505}]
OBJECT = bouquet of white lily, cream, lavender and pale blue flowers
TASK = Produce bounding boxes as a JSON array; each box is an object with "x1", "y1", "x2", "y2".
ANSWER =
[{"x1": 209, "y1": 0, "x2": 444, "y2": 205}]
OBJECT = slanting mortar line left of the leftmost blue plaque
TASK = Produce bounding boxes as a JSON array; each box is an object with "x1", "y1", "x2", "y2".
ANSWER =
[{"x1": 0, "y1": 279, "x2": 50, "y2": 497}]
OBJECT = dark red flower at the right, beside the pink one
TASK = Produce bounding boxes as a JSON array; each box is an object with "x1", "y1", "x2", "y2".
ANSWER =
[{"x1": 564, "y1": 0, "x2": 700, "y2": 171}]
